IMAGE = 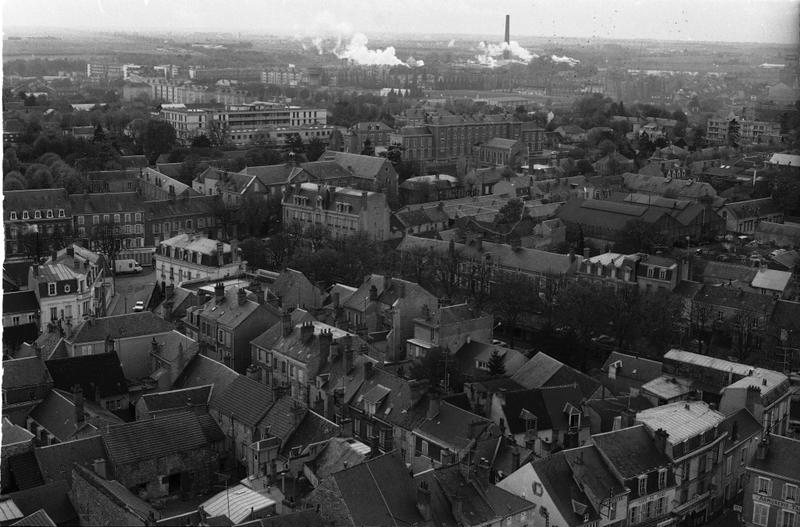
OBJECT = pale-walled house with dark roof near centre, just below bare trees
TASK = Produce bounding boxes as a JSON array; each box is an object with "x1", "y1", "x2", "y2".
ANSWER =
[{"x1": 406, "y1": 303, "x2": 494, "y2": 371}]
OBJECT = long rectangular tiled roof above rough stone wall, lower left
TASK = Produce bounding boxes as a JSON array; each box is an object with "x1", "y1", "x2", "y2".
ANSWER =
[{"x1": 103, "y1": 412, "x2": 208, "y2": 465}]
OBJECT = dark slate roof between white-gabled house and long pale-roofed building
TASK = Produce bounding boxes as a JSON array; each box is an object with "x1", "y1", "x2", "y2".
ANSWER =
[{"x1": 592, "y1": 425, "x2": 670, "y2": 479}]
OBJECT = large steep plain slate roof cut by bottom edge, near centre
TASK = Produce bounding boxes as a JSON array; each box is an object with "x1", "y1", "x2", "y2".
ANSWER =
[{"x1": 333, "y1": 452, "x2": 423, "y2": 525}]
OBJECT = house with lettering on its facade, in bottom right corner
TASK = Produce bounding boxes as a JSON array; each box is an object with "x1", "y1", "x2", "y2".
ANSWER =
[{"x1": 742, "y1": 435, "x2": 800, "y2": 527}]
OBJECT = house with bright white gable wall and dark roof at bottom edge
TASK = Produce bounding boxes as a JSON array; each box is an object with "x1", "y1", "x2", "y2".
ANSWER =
[{"x1": 497, "y1": 446, "x2": 629, "y2": 527}]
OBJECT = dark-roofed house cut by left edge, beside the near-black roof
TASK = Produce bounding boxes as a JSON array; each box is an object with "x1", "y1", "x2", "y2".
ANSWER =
[{"x1": 3, "y1": 357, "x2": 53, "y2": 428}]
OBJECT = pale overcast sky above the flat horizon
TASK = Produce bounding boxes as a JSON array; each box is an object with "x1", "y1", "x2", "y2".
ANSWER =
[{"x1": 0, "y1": 0, "x2": 800, "y2": 43}]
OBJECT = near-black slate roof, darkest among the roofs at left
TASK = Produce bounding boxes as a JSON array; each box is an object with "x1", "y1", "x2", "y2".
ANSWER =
[{"x1": 45, "y1": 352, "x2": 128, "y2": 399}]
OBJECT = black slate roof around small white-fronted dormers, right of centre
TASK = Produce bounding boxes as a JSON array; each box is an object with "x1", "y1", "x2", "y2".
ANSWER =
[{"x1": 503, "y1": 386, "x2": 588, "y2": 434}]
